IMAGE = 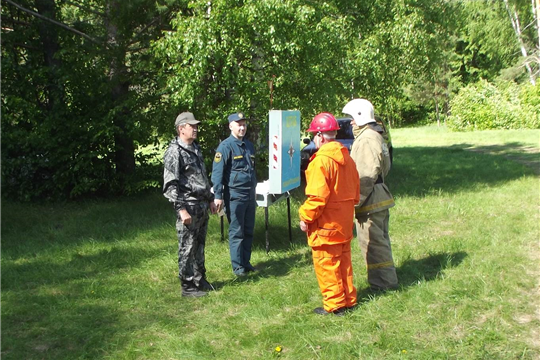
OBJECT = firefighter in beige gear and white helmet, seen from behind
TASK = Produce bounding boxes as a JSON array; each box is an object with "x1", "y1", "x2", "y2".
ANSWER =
[{"x1": 343, "y1": 99, "x2": 398, "y2": 291}]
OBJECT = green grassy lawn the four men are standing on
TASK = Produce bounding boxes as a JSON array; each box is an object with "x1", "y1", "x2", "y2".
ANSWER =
[{"x1": 1, "y1": 127, "x2": 540, "y2": 360}]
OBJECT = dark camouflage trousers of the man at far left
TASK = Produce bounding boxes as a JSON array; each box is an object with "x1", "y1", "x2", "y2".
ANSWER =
[{"x1": 176, "y1": 203, "x2": 209, "y2": 285}]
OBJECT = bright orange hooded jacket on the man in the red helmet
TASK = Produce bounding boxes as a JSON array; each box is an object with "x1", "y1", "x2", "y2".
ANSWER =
[{"x1": 298, "y1": 141, "x2": 360, "y2": 247}]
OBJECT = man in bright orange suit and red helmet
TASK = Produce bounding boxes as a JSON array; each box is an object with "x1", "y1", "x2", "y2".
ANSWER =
[{"x1": 298, "y1": 113, "x2": 360, "y2": 315}]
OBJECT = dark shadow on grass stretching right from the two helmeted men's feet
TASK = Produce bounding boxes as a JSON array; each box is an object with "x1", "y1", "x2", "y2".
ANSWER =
[{"x1": 358, "y1": 251, "x2": 467, "y2": 304}]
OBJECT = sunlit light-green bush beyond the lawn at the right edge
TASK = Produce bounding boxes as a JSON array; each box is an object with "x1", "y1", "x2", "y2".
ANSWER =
[{"x1": 448, "y1": 80, "x2": 540, "y2": 131}]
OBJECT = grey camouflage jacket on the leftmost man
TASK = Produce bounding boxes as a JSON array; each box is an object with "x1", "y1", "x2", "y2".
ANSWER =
[{"x1": 163, "y1": 137, "x2": 214, "y2": 211}]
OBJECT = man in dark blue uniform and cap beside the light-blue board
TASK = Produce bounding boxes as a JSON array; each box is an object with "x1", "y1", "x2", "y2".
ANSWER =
[{"x1": 212, "y1": 113, "x2": 257, "y2": 276}]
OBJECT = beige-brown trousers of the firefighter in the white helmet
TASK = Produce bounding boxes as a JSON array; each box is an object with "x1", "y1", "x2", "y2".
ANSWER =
[{"x1": 356, "y1": 209, "x2": 398, "y2": 290}]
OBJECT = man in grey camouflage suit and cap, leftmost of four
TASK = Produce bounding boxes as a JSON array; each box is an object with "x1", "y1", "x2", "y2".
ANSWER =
[{"x1": 163, "y1": 112, "x2": 216, "y2": 297}]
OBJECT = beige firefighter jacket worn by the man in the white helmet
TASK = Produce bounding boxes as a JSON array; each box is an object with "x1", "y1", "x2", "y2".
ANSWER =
[{"x1": 351, "y1": 124, "x2": 395, "y2": 215}]
